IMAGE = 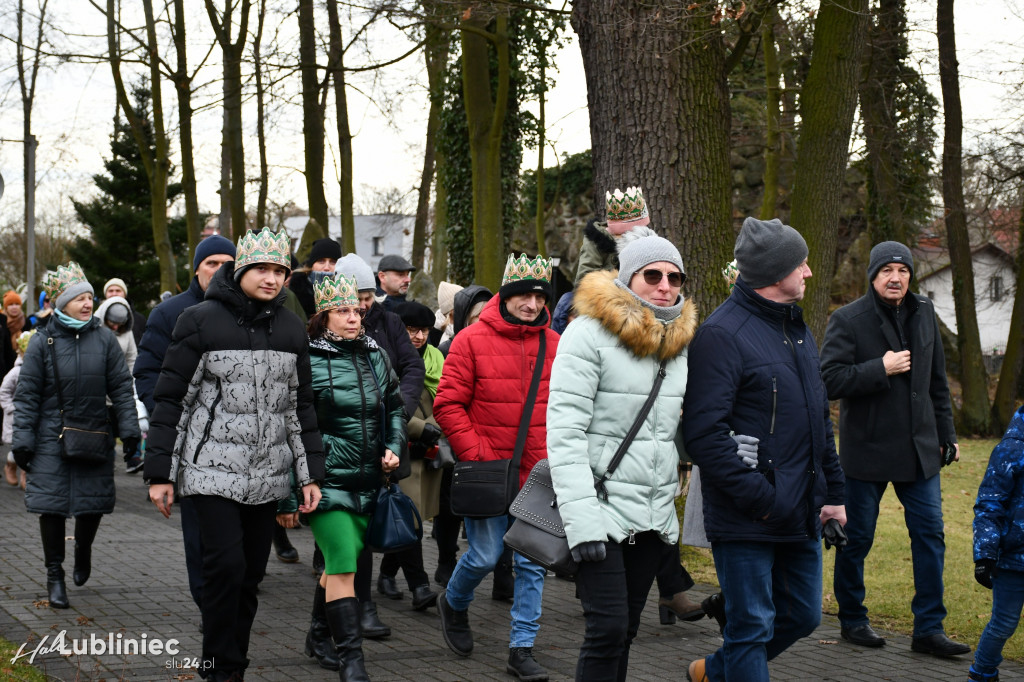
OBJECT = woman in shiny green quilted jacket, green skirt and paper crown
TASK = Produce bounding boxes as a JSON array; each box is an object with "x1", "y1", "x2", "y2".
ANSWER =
[{"x1": 279, "y1": 274, "x2": 406, "y2": 682}]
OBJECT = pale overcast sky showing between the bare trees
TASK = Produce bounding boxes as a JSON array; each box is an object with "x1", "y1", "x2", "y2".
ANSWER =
[{"x1": 0, "y1": 0, "x2": 1024, "y2": 232}]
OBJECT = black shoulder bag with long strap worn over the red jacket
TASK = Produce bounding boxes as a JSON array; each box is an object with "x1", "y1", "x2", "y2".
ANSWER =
[{"x1": 452, "y1": 330, "x2": 547, "y2": 518}]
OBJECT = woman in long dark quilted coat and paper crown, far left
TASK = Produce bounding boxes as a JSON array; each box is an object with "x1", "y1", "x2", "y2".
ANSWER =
[{"x1": 11, "y1": 262, "x2": 139, "y2": 608}]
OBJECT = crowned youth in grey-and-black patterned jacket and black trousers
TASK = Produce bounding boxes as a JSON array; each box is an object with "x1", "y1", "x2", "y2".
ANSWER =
[{"x1": 144, "y1": 227, "x2": 324, "y2": 680}]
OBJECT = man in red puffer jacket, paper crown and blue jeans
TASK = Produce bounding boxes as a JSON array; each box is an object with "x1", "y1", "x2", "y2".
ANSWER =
[{"x1": 434, "y1": 255, "x2": 558, "y2": 681}]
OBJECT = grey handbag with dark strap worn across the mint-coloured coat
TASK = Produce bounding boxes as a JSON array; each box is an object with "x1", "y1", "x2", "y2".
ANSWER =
[{"x1": 505, "y1": 361, "x2": 665, "y2": 576}]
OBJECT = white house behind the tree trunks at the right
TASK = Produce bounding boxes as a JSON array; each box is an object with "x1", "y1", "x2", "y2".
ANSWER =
[{"x1": 914, "y1": 243, "x2": 1016, "y2": 355}]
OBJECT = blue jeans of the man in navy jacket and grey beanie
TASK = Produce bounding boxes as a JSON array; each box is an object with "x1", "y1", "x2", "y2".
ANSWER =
[{"x1": 706, "y1": 539, "x2": 821, "y2": 682}]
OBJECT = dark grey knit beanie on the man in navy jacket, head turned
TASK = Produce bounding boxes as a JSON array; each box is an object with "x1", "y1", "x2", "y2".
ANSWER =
[{"x1": 732, "y1": 218, "x2": 808, "y2": 289}]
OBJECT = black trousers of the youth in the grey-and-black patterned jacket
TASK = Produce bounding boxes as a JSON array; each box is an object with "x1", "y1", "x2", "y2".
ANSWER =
[{"x1": 190, "y1": 495, "x2": 278, "y2": 675}]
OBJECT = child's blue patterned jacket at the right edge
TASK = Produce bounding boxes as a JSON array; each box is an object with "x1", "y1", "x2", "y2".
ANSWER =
[{"x1": 970, "y1": 408, "x2": 1024, "y2": 570}]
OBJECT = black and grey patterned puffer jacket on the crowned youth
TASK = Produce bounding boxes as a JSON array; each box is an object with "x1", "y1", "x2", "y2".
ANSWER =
[{"x1": 145, "y1": 263, "x2": 324, "y2": 505}]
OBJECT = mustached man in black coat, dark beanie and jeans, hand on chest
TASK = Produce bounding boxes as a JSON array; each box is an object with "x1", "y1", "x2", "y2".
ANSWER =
[{"x1": 815, "y1": 242, "x2": 971, "y2": 656}]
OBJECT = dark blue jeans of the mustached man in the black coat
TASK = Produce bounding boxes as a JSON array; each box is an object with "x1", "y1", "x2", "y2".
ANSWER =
[{"x1": 833, "y1": 474, "x2": 946, "y2": 637}]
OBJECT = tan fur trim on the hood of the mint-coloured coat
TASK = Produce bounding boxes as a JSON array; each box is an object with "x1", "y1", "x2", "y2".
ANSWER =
[{"x1": 572, "y1": 270, "x2": 697, "y2": 359}]
